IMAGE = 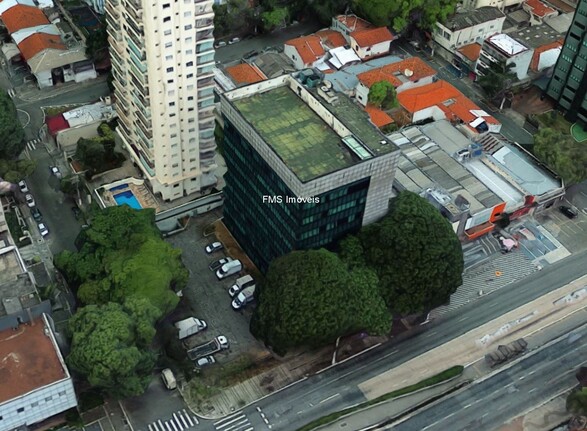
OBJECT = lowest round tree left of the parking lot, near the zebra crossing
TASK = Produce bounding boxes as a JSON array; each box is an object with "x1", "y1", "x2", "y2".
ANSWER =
[{"x1": 67, "y1": 298, "x2": 155, "y2": 397}]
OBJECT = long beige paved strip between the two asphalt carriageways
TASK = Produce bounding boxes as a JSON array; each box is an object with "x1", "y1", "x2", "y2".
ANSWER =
[{"x1": 359, "y1": 276, "x2": 587, "y2": 400}]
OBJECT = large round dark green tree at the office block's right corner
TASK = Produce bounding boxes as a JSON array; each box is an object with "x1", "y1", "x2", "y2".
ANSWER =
[{"x1": 341, "y1": 192, "x2": 464, "y2": 314}]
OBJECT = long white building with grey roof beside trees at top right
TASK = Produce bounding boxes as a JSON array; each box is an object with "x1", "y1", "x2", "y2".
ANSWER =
[{"x1": 432, "y1": 7, "x2": 506, "y2": 61}]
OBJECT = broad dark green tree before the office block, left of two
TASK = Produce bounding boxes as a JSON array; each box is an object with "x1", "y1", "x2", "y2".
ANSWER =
[{"x1": 251, "y1": 249, "x2": 391, "y2": 354}]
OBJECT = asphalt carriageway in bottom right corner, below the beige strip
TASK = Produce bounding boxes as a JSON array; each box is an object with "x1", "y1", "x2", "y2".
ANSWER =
[{"x1": 389, "y1": 325, "x2": 587, "y2": 431}]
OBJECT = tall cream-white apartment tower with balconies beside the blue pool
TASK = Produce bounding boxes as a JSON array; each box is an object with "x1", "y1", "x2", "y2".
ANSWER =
[{"x1": 106, "y1": 0, "x2": 217, "y2": 201}]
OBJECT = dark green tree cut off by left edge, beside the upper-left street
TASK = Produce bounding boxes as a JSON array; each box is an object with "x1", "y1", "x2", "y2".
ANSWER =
[{"x1": 0, "y1": 90, "x2": 25, "y2": 160}]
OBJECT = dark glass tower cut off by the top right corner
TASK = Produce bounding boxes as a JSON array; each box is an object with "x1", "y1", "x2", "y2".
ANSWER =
[{"x1": 546, "y1": 0, "x2": 587, "y2": 128}]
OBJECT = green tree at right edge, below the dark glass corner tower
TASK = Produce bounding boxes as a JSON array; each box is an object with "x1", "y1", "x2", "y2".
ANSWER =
[{"x1": 534, "y1": 127, "x2": 587, "y2": 185}]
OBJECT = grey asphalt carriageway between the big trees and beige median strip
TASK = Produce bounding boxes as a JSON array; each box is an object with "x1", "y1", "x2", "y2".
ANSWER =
[{"x1": 237, "y1": 252, "x2": 587, "y2": 431}]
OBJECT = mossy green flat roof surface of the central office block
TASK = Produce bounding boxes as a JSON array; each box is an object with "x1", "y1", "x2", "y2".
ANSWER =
[{"x1": 233, "y1": 86, "x2": 356, "y2": 182}]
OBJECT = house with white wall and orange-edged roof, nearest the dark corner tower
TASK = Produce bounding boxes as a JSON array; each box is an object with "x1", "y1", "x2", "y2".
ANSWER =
[{"x1": 509, "y1": 24, "x2": 565, "y2": 72}]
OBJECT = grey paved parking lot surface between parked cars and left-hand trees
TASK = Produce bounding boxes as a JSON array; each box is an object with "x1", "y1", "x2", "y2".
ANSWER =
[{"x1": 168, "y1": 210, "x2": 266, "y2": 364}]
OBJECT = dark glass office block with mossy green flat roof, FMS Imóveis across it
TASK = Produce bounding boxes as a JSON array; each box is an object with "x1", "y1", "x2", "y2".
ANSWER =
[{"x1": 221, "y1": 70, "x2": 399, "y2": 272}]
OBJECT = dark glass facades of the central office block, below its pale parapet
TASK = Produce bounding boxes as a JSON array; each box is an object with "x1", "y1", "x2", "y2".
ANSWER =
[{"x1": 224, "y1": 119, "x2": 369, "y2": 272}]
